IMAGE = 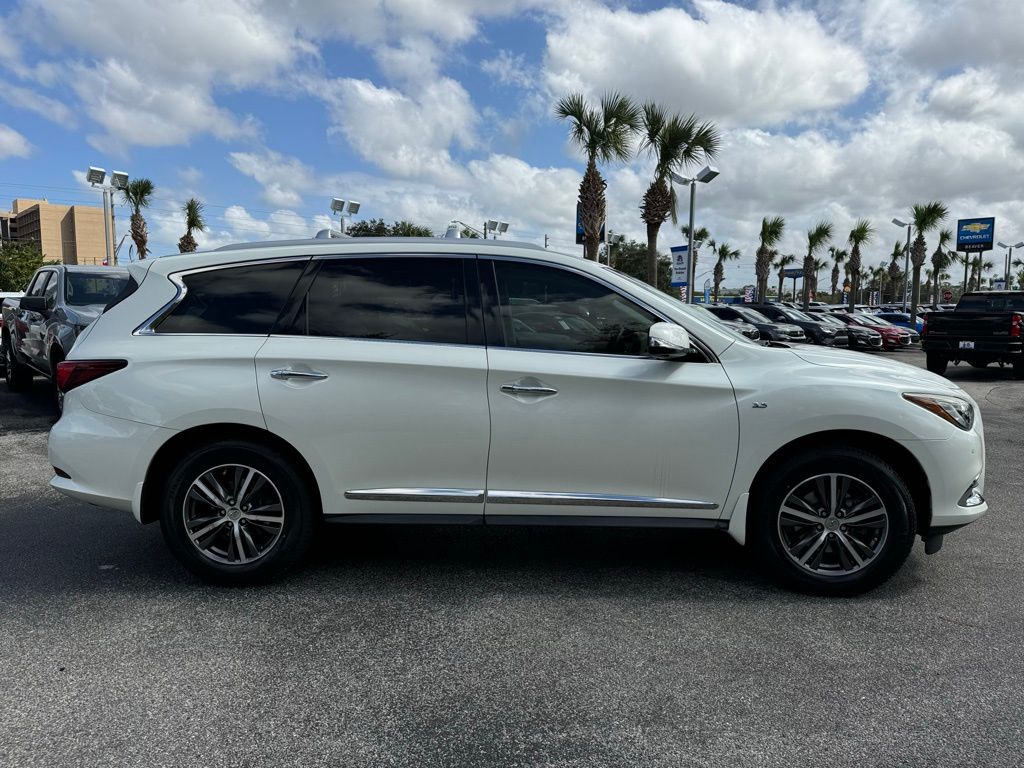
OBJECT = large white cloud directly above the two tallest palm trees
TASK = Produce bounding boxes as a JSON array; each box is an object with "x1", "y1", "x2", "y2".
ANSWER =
[{"x1": 545, "y1": 0, "x2": 868, "y2": 125}]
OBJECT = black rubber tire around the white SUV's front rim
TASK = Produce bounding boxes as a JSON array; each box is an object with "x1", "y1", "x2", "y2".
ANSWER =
[{"x1": 749, "y1": 447, "x2": 916, "y2": 597}]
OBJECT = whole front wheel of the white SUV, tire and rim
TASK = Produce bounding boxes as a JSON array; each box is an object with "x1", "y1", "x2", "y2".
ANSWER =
[{"x1": 751, "y1": 449, "x2": 915, "y2": 595}]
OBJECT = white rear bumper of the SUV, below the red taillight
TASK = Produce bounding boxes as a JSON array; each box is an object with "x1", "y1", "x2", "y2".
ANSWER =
[{"x1": 48, "y1": 399, "x2": 174, "y2": 519}]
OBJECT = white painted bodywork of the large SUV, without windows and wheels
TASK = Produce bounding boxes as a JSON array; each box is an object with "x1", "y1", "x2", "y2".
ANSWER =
[{"x1": 44, "y1": 240, "x2": 987, "y2": 541}]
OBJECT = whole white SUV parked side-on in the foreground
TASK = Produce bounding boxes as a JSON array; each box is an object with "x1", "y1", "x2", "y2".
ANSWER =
[{"x1": 49, "y1": 239, "x2": 987, "y2": 594}]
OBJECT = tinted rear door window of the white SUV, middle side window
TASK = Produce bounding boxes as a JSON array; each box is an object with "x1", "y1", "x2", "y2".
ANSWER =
[{"x1": 291, "y1": 256, "x2": 475, "y2": 344}]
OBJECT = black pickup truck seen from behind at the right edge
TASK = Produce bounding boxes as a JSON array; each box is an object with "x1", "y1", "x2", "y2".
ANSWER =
[{"x1": 921, "y1": 291, "x2": 1024, "y2": 379}]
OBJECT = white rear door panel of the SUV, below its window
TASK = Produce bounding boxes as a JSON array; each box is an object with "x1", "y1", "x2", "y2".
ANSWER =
[{"x1": 256, "y1": 336, "x2": 488, "y2": 515}]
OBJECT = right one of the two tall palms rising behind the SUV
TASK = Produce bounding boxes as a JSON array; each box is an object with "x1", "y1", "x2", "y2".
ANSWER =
[{"x1": 640, "y1": 102, "x2": 721, "y2": 286}]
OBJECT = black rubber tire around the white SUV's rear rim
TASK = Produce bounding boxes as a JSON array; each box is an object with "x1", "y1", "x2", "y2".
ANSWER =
[{"x1": 160, "y1": 440, "x2": 318, "y2": 587}]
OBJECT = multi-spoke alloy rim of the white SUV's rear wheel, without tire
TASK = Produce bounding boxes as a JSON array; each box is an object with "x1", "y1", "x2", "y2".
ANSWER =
[{"x1": 182, "y1": 464, "x2": 285, "y2": 565}]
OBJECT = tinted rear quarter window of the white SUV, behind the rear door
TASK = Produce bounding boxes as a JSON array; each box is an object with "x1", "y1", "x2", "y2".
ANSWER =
[{"x1": 156, "y1": 259, "x2": 306, "y2": 336}]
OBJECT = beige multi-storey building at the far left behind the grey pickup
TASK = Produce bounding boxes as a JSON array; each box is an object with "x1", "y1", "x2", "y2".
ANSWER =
[{"x1": 0, "y1": 198, "x2": 113, "y2": 264}]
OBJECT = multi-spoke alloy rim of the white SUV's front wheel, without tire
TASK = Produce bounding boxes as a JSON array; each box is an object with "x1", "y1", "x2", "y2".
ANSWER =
[{"x1": 777, "y1": 473, "x2": 889, "y2": 577}]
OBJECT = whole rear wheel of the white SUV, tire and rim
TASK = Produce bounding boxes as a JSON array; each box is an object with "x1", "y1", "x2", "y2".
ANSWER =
[{"x1": 160, "y1": 441, "x2": 316, "y2": 586}]
